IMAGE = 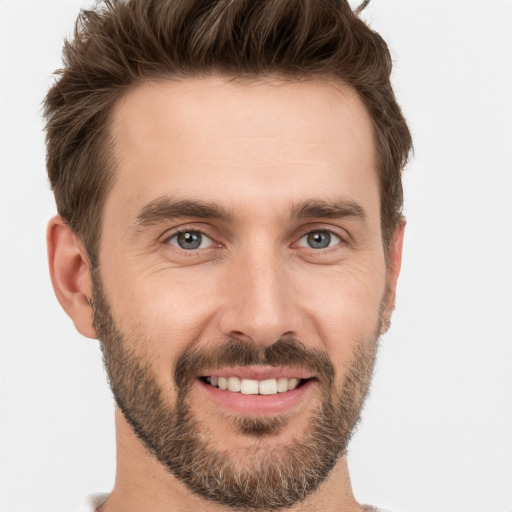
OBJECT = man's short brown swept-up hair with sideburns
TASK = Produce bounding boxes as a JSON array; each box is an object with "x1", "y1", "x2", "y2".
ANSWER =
[{"x1": 44, "y1": 0, "x2": 412, "y2": 263}]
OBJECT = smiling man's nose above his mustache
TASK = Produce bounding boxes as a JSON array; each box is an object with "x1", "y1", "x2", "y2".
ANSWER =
[{"x1": 220, "y1": 245, "x2": 300, "y2": 347}]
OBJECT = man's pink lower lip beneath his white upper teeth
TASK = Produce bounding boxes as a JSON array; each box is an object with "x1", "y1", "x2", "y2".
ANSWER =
[{"x1": 197, "y1": 379, "x2": 316, "y2": 416}]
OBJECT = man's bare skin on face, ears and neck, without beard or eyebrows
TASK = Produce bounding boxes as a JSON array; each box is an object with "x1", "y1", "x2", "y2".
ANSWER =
[{"x1": 48, "y1": 76, "x2": 404, "y2": 512}]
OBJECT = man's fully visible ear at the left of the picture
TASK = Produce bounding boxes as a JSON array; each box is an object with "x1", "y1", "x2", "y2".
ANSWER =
[{"x1": 46, "y1": 215, "x2": 97, "y2": 339}]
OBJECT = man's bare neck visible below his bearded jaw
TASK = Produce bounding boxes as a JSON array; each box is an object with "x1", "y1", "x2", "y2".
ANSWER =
[{"x1": 97, "y1": 409, "x2": 363, "y2": 512}]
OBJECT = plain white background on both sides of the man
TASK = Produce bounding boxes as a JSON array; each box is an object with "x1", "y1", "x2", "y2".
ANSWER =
[{"x1": 0, "y1": 0, "x2": 512, "y2": 512}]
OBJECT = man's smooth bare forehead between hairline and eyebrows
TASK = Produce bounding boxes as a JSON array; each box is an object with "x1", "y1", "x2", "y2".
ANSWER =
[{"x1": 105, "y1": 77, "x2": 378, "y2": 225}]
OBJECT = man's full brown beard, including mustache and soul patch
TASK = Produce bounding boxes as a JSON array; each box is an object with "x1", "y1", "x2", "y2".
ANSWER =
[{"x1": 91, "y1": 269, "x2": 386, "y2": 512}]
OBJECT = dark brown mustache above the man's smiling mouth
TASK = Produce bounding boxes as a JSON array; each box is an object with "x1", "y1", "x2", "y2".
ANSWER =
[{"x1": 174, "y1": 337, "x2": 335, "y2": 389}]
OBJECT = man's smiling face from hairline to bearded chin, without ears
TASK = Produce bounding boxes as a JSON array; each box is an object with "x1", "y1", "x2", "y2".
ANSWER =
[{"x1": 94, "y1": 77, "x2": 388, "y2": 508}]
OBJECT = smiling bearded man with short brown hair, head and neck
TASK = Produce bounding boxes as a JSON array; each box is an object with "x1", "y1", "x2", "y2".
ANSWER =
[{"x1": 45, "y1": 0, "x2": 411, "y2": 512}]
